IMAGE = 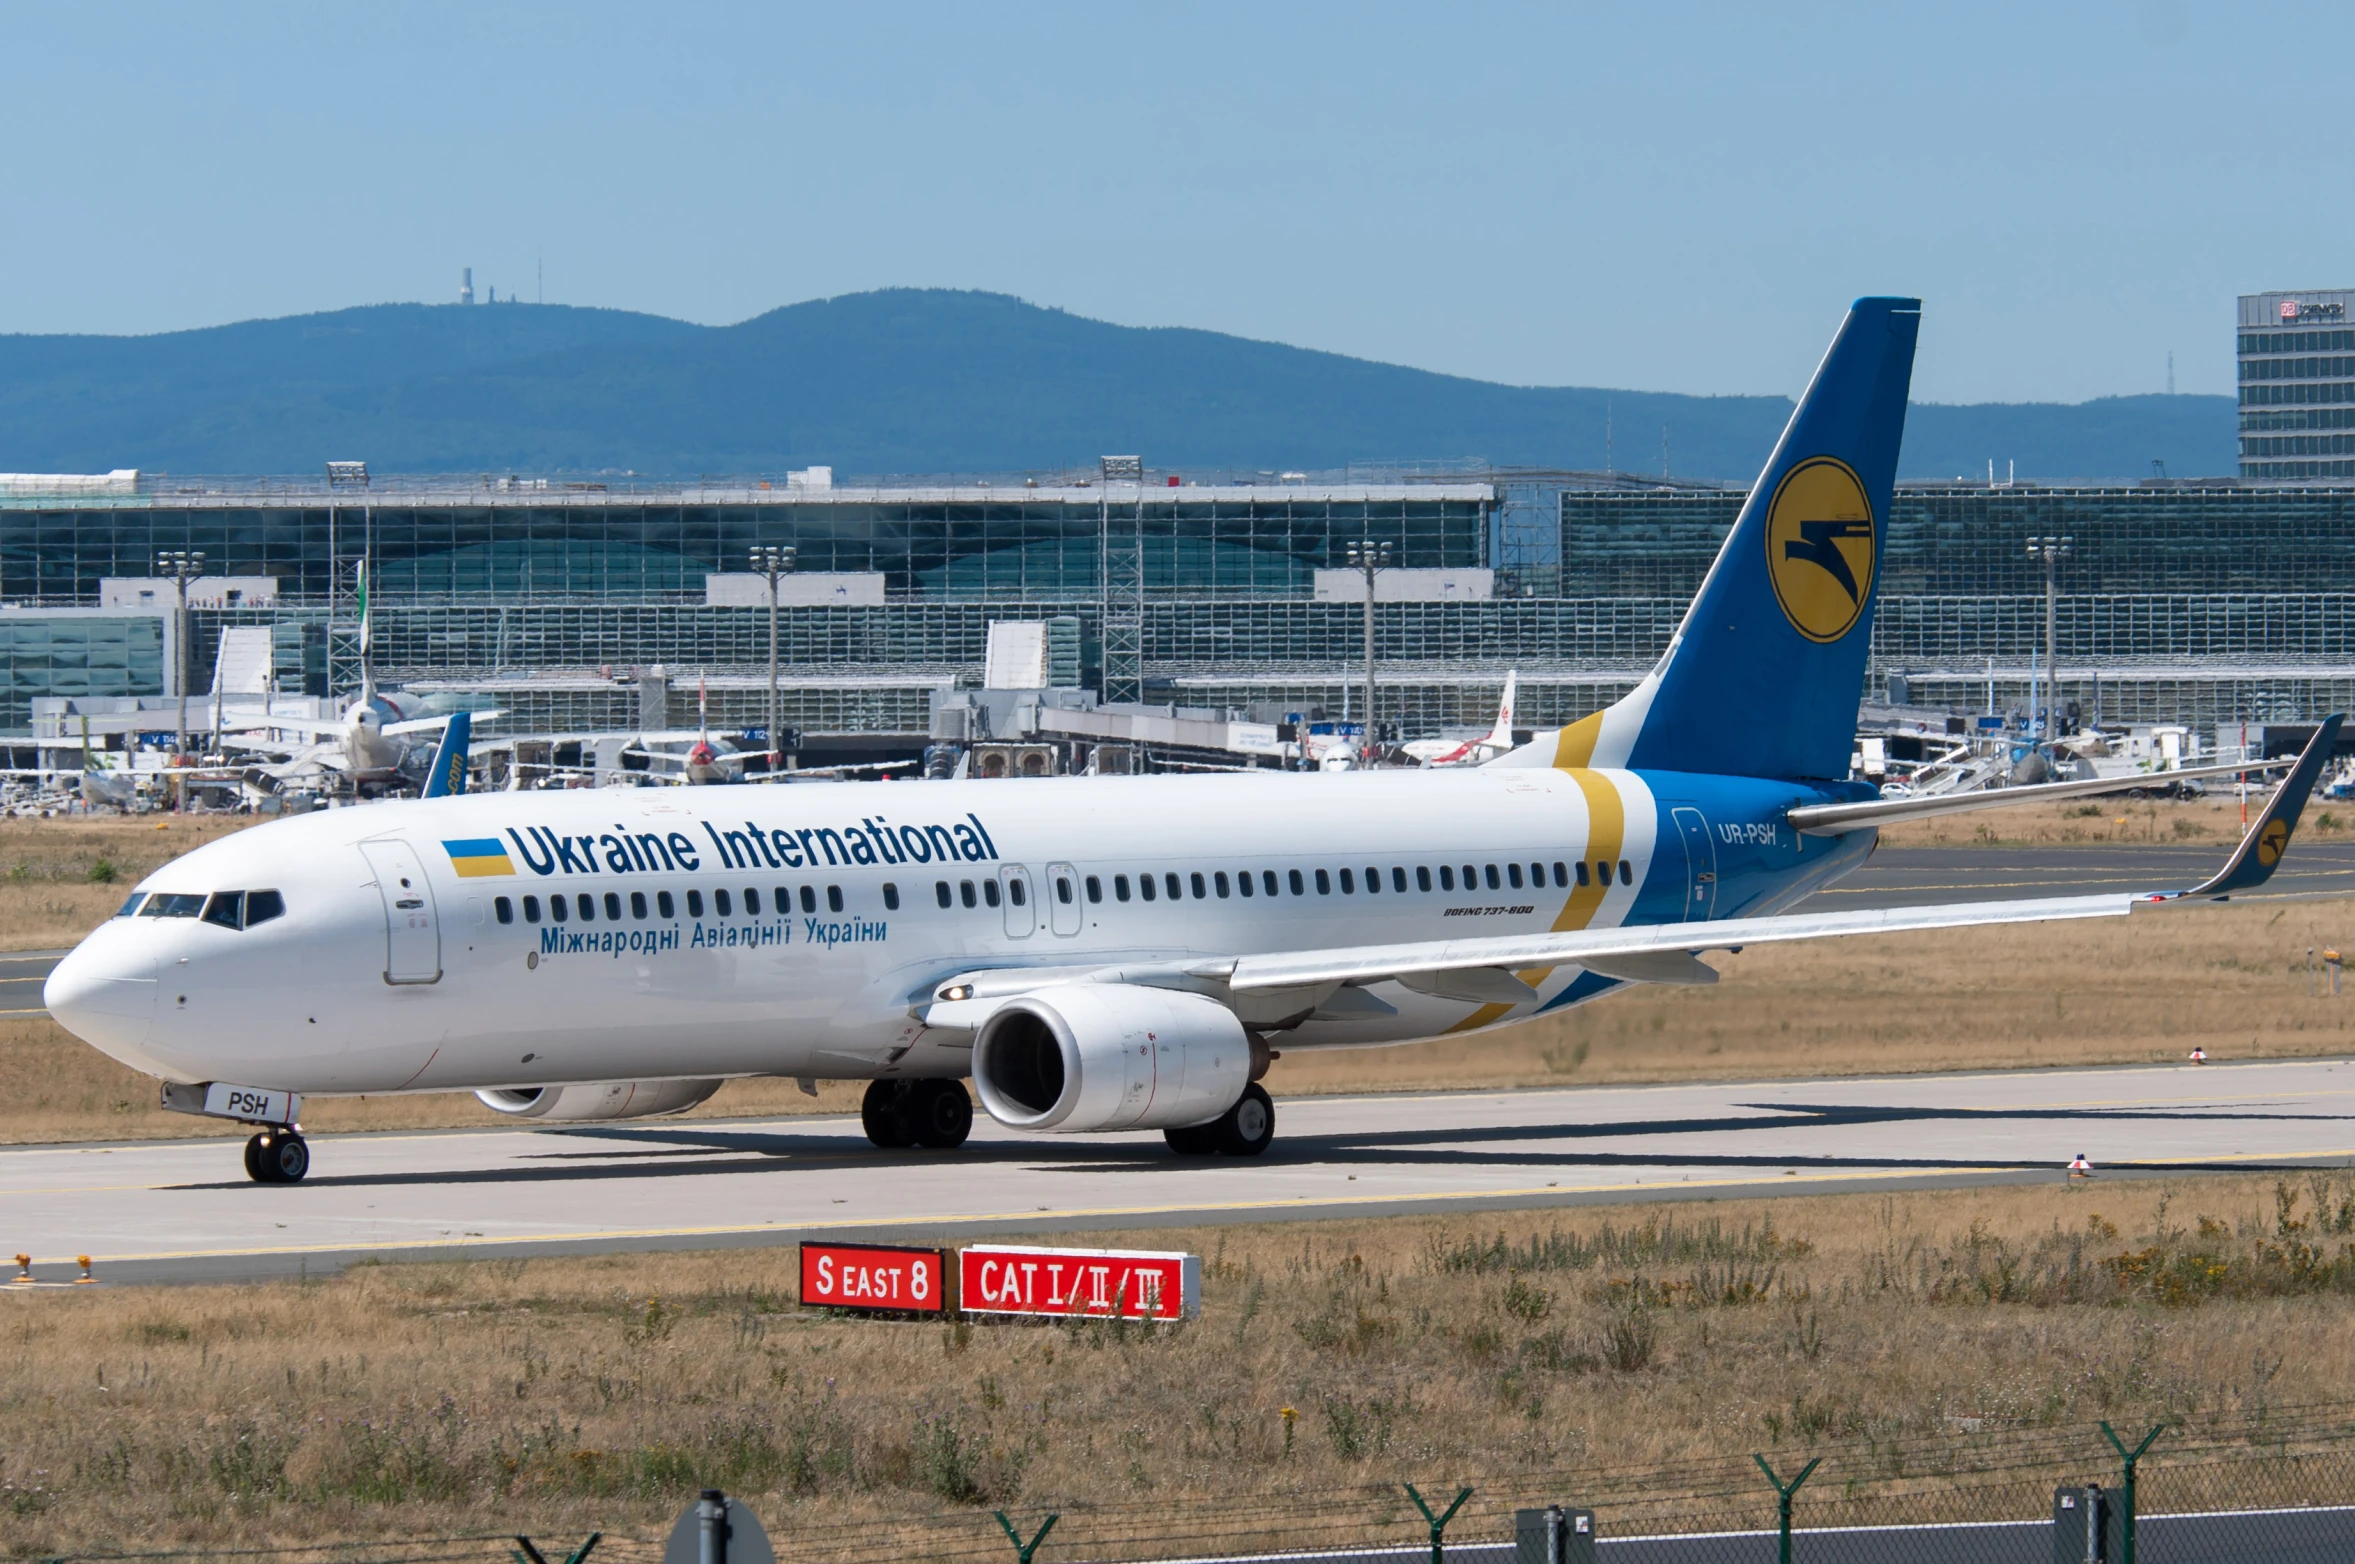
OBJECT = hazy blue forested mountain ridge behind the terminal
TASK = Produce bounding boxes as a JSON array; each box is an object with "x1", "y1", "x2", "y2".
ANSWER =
[{"x1": 0, "y1": 290, "x2": 2237, "y2": 481}]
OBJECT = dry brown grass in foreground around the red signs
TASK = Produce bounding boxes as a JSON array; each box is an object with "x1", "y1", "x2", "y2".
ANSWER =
[{"x1": 0, "y1": 1175, "x2": 2355, "y2": 1557}]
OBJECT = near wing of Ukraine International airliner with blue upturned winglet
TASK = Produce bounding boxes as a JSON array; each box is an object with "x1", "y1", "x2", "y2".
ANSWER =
[{"x1": 918, "y1": 716, "x2": 2343, "y2": 1027}]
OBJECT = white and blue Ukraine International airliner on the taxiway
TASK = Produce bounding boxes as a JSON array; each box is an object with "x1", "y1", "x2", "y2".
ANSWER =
[{"x1": 47, "y1": 299, "x2": 2339, "y2": 1182}]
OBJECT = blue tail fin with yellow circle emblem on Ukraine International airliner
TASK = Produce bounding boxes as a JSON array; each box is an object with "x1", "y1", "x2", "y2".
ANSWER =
[{"x1": 1498, "y1": 299, "x2": 1922, "y2": 777}]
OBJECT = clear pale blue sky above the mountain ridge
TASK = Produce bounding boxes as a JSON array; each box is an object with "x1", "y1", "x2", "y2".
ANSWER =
[{"x1": 0, "y1": 0, "x2": 2355, "y2": 400}]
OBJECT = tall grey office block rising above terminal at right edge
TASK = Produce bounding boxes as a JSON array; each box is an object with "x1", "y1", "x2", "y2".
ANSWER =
[{"x1": 2235, "y1": 292, "x2": 2355, "y2": 478}]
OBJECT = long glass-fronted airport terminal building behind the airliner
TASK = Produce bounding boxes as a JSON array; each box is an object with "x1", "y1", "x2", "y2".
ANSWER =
[{"x1": 0, "y1": 464, "x2": 2355, "y2": 737}]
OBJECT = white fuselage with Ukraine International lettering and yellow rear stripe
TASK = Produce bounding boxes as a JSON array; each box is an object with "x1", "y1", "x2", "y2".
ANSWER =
[{"x1": 32, "y1": 768, "x2": 1836, "y2": 1093}]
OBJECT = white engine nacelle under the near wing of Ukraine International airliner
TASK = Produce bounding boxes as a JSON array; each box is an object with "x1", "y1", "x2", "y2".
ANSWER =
[{"x1": 973, "y1": 982, "x2": 1251, "y2": 1135}]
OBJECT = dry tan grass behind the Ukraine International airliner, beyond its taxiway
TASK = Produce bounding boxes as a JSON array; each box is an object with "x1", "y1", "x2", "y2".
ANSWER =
[{"x1": 0, "y1": 801, "x2": 2355, "y2": 1140}]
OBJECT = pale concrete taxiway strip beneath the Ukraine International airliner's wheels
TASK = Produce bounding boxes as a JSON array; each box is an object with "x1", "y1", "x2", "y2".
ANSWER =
[{"x1": 0, "y1": 1060, "x2": 2355, "y2": 1281}]
